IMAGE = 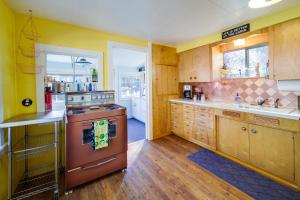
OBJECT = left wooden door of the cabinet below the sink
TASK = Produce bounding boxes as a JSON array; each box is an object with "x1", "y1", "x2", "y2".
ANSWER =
[{"x1": 217, "y1": 117, "x2": 249, "y2": 162}]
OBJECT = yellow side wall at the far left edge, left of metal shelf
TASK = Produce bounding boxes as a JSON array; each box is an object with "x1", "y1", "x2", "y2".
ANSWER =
[{"x1": 0, "y1": 0, "x2": 17, "y2": 200}]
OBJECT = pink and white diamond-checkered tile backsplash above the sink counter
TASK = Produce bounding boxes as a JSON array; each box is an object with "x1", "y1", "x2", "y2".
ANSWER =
[{"x1": 181, "y1": 78, "x2": 300, "y2": 108}]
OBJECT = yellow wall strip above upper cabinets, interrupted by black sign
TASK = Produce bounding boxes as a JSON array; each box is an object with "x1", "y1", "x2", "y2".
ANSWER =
[{"x1": 176, "y1": 4, "x2": 300, "y2": 52}]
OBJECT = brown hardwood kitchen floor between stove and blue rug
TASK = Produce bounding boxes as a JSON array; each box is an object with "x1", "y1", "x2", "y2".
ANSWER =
[{"x1": 38, "y1": 135, "x2": 251, "y2": 200}]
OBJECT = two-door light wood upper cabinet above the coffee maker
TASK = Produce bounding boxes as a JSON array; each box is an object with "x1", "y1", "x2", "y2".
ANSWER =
[{"x1": 179, "y1": 45, "x2": 211, "y2": 82}]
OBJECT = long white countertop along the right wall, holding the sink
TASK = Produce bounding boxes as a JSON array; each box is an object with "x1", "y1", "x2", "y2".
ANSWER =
[{"x1": 170, "y1": 99, "x2": 300, "y2": 120}]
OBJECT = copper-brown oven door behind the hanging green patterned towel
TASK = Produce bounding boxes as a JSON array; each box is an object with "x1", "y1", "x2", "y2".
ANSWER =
[{"x1": 66, "y1": 115, "x2": 127, "y2": 170}]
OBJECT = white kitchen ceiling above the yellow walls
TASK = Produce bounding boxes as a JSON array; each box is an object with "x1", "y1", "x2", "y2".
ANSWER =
[{"x1": 7, "y1": 0, "x2": 300, "y2": 45}]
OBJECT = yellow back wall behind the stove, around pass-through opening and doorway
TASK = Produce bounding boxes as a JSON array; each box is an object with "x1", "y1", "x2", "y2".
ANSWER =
[{"x1": 16, "y1": 14, "x2": 147, "y2": 113}]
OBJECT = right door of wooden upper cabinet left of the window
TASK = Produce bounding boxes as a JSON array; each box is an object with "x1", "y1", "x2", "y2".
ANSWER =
[{"x1": 191, "y1": 45, "x2": 211, "y2": 82}]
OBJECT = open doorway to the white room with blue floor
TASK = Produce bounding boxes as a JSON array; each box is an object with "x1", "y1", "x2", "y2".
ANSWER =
[{"x1": 109, "y1": 43, "x2": 149, "y2": 143}]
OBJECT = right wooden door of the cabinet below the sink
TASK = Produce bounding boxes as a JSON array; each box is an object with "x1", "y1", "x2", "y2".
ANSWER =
[{"x1": 249, "y1": 124, "x2": 294, "y2": 181}]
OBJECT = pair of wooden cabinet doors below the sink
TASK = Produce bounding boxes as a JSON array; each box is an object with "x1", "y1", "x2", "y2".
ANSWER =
[{"x1": 217, "y1": 117, "x2": 295, "y2": 182}]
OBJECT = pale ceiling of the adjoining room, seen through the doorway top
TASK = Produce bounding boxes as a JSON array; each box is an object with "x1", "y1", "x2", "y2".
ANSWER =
[{"x1": 113, "y1": 48, "x2": 146, "y2": 68}]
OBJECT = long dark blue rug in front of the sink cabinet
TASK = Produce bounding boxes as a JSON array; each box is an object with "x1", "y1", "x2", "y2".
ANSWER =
[{"x1": 188, "y1": 149, "x2": 300, "y2": 200}]
